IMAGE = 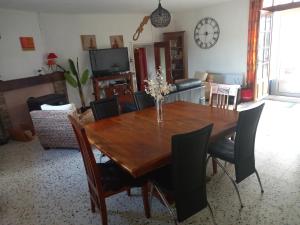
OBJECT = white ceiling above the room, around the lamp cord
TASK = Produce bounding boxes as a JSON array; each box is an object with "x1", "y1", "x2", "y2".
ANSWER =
[{"x1": 0, "y1": 0, "x2": 228, "y2": 14}]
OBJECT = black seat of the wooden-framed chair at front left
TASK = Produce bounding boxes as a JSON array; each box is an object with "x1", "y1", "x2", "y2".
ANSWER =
[{"x1": 97, "y1": 160, "x2": 145, "y2": 191}]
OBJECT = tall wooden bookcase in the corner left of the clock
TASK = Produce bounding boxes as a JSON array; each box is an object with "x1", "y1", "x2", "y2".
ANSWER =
[{"x1": 164, "y1": 31, "x2": 187, "y2": 82}]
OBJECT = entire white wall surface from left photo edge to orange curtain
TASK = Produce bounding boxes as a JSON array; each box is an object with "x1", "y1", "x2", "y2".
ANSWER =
[{"x1": 0, "y1": 0, "x2": 249, "y2": 105}]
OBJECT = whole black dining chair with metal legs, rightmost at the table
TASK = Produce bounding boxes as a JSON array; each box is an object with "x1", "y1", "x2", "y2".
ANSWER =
[{"x1": 207, "y1": 103, "x2": 264, "y2": 208}]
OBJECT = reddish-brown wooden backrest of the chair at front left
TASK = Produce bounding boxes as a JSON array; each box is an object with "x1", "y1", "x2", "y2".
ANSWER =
[{"x1": 68, "y1": 115, "x2": 104, "y2": 202}]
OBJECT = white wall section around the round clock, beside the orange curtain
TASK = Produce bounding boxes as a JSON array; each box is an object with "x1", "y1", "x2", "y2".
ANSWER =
[{"x1": 173, "y1": 0, "x2": 249, "y2": 77}]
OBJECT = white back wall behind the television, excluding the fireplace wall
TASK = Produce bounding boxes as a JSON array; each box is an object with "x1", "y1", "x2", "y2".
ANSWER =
[{"x1": 39, "y1": 13, "x2": 174, "y2": 103}]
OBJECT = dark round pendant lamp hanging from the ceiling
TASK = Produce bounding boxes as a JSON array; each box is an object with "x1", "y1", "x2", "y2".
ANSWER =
[{"x1": 150, "y1": 0, "x2": 171, "y2": 27}]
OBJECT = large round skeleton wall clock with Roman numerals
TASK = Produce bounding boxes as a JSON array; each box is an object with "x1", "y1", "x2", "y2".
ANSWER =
[{"x1": 194, "y1": 17, "x2": 220, "y2": 49}]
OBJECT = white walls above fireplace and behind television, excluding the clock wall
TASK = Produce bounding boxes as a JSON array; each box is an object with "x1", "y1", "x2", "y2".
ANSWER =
[{"x1": 0, "y1": 9, "x2": 174, "y2": 106}]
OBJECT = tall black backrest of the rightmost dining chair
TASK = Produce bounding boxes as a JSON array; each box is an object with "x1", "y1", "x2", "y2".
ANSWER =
[{"x1": 234, "y1": 103, "x2": 265, "y2": 183}]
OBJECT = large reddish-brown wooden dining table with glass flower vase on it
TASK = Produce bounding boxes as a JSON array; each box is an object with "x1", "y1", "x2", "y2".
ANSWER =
[{"x1": 85, "y1": 101, "x2": 238, "y2": 177}]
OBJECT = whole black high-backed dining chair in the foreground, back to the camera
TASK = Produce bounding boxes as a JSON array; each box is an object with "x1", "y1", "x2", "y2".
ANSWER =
[{"x1": 150, "y1": 124, "x2": 215, "y2": 224}]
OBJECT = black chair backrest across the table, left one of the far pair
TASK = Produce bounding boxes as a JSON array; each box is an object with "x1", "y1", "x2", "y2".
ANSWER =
[{"x1": 90, "y1": 97, "x2": 120, "y2": 120}]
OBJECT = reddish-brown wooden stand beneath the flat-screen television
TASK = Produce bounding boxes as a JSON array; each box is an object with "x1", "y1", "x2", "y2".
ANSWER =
[{"x1": 92, "y1": 72, "x2": 134, "y2": 106}]
